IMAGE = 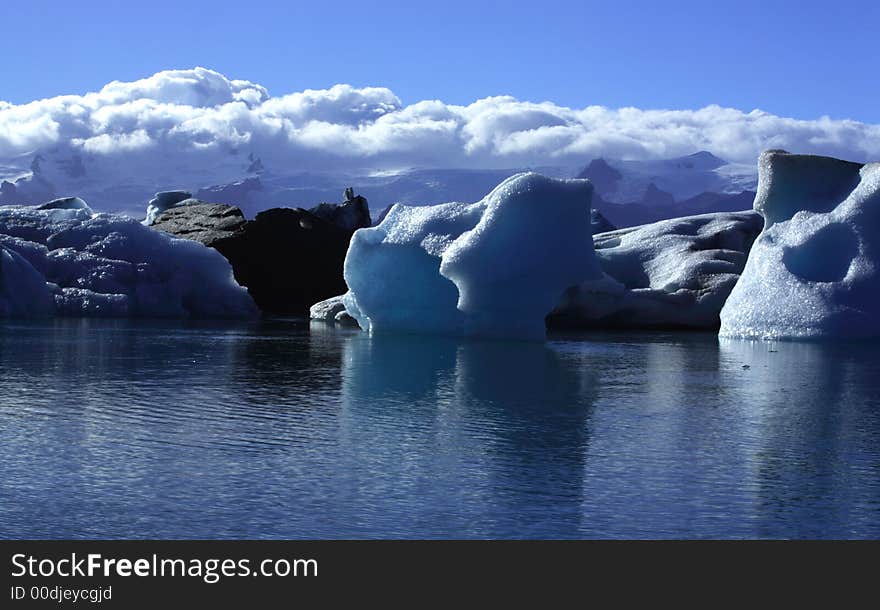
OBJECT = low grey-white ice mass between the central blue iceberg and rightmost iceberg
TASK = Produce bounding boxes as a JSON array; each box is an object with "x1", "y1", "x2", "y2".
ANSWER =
[{"x1": 549, "y1": 211, "x2": 763, "y2": 328}]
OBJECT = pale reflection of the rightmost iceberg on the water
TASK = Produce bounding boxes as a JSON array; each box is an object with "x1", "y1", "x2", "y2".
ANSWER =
[{"x1": 721, "y1": 340, "x2": 880, "y2": 537}]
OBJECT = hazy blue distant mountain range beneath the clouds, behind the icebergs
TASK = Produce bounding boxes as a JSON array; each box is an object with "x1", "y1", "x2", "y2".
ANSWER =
[{"x1": 0, "y1": 149, "x2": 757, "y2": 227}]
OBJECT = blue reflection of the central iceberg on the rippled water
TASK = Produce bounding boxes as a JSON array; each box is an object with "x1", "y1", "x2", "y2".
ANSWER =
[{"x1": 342, "y1": 335, "x2": 595, "y2": 537}]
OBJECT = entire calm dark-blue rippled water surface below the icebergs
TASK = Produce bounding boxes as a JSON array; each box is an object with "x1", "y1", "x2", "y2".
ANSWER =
[{"x1": 0, "y1": 321, "x2": 880, "y2": 538}]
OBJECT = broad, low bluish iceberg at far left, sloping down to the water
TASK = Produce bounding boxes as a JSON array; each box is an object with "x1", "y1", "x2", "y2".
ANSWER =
[{"x1": 0, "y1": 204, "x2": 257, "y2": 318}]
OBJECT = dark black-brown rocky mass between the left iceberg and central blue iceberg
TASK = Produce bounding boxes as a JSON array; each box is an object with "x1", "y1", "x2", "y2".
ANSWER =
[{"x1": 152, "y1": 188, "x2": 370, "y2": 316}]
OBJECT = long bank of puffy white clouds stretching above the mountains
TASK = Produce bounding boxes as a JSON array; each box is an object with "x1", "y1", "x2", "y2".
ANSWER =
[{"x1": 0, "y1": 68, "x2": 880, "y2": 176}]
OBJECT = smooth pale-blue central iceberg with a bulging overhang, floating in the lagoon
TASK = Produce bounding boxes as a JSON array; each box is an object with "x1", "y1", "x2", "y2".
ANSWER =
[{"x1": 344, "y1": 173, "x2": 602, "y2": 339}]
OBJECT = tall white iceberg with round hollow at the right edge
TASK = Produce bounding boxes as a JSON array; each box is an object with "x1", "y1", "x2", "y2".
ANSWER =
[{"x1": 720, "y1": 150, "x2": 880, "y2": 339}]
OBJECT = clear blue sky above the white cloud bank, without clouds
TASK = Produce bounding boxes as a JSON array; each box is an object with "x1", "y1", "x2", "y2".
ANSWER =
[{"x1": 0, "y1": 0, "x2": 880, "y2": 122}]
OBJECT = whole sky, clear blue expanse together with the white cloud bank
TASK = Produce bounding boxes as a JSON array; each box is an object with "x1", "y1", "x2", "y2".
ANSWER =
[{"x1": 0, "y1": 0, "x2": 880, "y2": 184}]
